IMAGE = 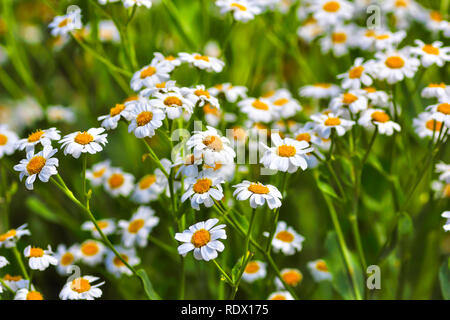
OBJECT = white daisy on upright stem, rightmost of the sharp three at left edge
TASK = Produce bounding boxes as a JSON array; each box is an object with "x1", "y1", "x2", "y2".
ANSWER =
[{"x1": 59, "y1": 128, "x2": 108, "y2": 159}]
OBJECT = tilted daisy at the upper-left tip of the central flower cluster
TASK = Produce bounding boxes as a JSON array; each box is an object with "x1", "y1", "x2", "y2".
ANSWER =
[{"x1": 130, "y1": 58, "x2": 174, "y2": 91}]
